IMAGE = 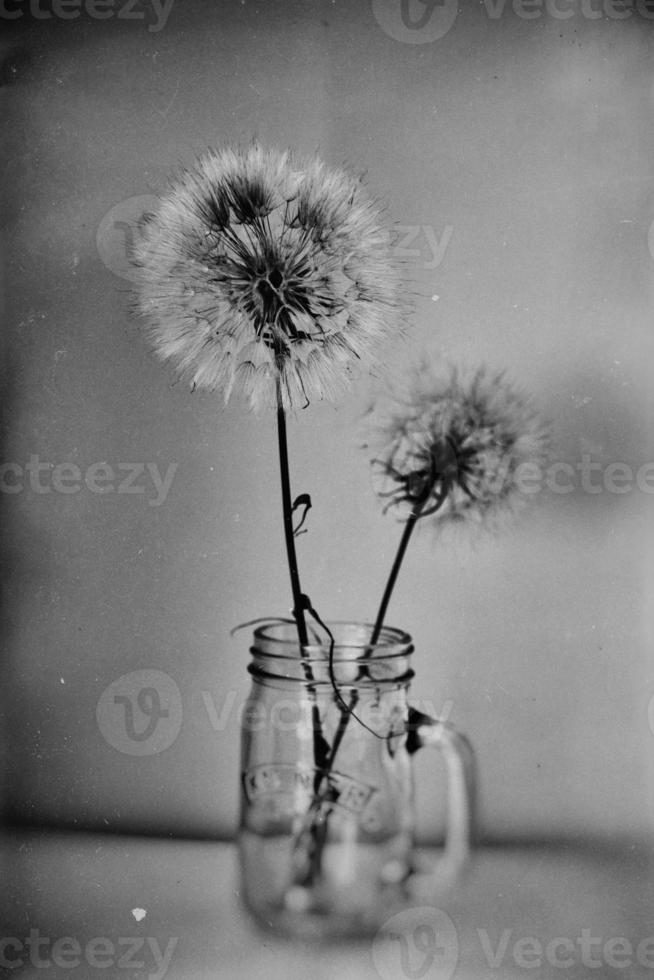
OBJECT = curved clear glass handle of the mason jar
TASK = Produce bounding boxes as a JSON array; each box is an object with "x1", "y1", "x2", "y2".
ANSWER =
[{"x1": 406, "y1": 707, "x2": 476, "y2": 897}]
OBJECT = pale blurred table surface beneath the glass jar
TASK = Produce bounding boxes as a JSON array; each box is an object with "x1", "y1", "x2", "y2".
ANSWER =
[{"x1": 0, "y1": 831, "x2": 654, "y2": 980}]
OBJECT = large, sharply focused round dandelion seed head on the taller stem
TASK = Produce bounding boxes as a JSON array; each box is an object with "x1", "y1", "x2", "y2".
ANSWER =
[{"x1": 133, "y1": 145, "x2": 401, "y2": 408}]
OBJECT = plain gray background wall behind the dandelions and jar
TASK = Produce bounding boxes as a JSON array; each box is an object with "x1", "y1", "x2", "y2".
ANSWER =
[{"x1": 0, "y1": 0, "x2": 654, "y2": 838}]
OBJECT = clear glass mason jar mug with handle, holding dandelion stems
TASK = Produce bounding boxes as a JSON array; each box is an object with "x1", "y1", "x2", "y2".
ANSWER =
[{"x1": 239, "y1": 621, "x2": 473, "y2": 939}]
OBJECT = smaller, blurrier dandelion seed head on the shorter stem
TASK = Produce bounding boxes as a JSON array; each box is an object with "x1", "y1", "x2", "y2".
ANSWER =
[{"x1": 372, "y1": 368, "x2": 548, "y2": 523}]
